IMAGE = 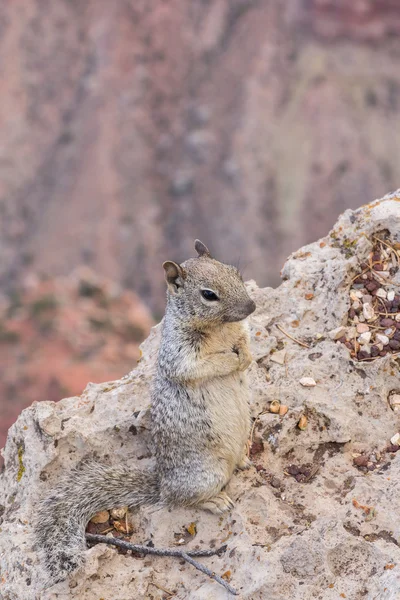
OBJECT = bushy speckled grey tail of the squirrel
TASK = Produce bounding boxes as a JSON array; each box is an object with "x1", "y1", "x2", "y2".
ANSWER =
[{"x1": 34, "y1": 462, "x2": 159, "y2": 584}]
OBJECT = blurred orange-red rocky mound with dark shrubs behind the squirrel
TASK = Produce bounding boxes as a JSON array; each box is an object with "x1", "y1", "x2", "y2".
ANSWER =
[{"x1": 0, "y1": 267, "x2": 153, "y2": 463}]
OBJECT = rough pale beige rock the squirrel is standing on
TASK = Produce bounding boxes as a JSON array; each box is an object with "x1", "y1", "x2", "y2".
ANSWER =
[{"x1": 0, "y1": 190, "x2": 400, "y2": 600}]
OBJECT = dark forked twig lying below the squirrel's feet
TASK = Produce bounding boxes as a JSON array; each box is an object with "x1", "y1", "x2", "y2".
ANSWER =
[{"x1": 86, "y1": 533, "x2": 239, "y2": 596}]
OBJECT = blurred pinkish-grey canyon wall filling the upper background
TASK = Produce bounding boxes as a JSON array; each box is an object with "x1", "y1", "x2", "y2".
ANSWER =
[{"x1": 0, "y1": 0, "x2": 400, "y2": 446}]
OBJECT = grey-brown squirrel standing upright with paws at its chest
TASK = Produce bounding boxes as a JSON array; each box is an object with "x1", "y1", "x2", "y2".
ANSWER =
[{"x1": 34, "y1": 240, "x2": 256, "y2": 585}]
